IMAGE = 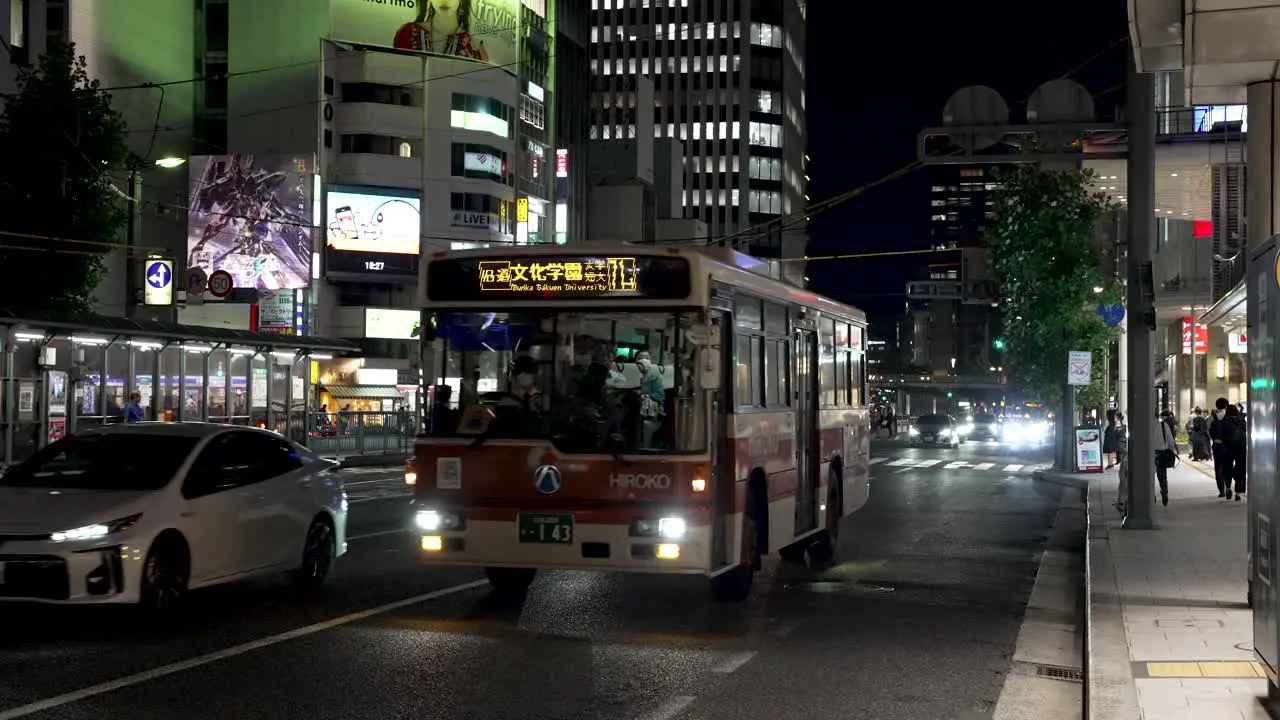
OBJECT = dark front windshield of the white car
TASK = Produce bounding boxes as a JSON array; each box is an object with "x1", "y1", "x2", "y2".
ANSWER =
[{"x1": 0, "y1": 433, "x2": 198, "y2": 491}]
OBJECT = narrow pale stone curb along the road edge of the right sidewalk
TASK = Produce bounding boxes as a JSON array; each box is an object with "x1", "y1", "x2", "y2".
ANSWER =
[{"x1": 1084, "y1": 477, "x2": 1142, "y2": 720}]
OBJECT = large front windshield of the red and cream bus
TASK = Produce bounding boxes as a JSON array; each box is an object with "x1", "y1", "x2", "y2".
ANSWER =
[{"x1": 424, "y1": 310, "x2": 707, "y2": 455}]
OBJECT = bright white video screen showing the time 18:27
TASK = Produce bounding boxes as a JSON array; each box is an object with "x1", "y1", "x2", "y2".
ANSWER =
[{"x1": 325, "y1": 188, "x2": 422, "y2": 274}]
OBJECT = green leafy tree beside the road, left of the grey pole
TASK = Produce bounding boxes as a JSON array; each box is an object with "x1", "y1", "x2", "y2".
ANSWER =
[{"x1": 988, "y1": 165, "x2": 1121, "y2": 405}]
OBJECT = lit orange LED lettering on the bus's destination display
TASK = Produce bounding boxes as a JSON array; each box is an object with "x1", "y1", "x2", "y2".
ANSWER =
[{"x1": 477, "y1": 258, "x2": 643, "y2": 296}]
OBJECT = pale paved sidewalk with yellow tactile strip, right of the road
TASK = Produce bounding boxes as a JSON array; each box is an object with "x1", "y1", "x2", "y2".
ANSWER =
[{"x1": 1085, "y1": 461, "x2": 1270, "y2": 720}]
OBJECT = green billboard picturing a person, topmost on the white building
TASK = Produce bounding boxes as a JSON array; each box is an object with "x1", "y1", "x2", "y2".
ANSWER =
[{"x1": 329, "y1": 0, "x2": 520, "y2": 72}]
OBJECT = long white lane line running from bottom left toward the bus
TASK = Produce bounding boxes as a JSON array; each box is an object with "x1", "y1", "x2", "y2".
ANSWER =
[{"x1": 0, "y1": 580, "x2": 488, "y2": 720}]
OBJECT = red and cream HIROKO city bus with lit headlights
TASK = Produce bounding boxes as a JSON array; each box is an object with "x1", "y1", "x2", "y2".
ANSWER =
[{"x1": 404, "y1": 242, "x2": 870, "y2": 601}]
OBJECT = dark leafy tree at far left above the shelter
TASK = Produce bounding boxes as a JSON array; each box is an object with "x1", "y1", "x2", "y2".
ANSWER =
[{"x1": 0, "y1": 45, "x2": 129, "y2": 315}]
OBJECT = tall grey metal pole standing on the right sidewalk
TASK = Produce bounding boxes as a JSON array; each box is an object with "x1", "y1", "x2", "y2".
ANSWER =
[{"x1": 1124, "y1": 58, "x2": 1157, "y2": 530}]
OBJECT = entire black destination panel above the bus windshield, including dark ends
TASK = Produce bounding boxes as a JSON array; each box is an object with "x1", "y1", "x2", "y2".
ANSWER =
[{"x1": 426, "y1": 255, "x2": 690, "y2": 301}]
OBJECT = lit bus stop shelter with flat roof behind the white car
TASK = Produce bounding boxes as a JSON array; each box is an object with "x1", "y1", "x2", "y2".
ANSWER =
[{"x1": 0, "y1": 313, "x2": 360, "y2": 465}]
